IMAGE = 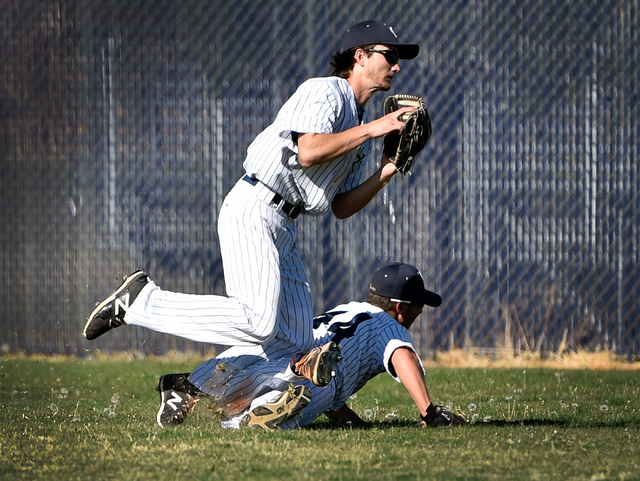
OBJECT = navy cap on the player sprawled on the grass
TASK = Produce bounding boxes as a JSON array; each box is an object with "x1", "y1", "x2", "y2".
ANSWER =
[{"x1": 369, "y1": 262, "x2": 442, "y2": 307}]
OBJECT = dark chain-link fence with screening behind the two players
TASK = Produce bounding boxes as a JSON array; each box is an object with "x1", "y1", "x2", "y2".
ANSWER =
[{"x1": 0, "y1": 0, "x2": 640, "y2": 357}]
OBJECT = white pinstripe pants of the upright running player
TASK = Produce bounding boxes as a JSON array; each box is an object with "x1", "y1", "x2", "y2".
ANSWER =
[{"x1": 125, "y1": 180, "x2": 313, "y2": 350}]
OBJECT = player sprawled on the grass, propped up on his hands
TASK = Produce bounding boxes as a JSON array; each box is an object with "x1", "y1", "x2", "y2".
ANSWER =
[{"x1": 158, "y1": 262, "x2": 464, "y2": 429}]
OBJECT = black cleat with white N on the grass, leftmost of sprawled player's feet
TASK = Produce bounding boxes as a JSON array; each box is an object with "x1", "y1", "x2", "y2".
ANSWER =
[{"x1": 156, "y1": 372, "x2": 201, "y2": 428}]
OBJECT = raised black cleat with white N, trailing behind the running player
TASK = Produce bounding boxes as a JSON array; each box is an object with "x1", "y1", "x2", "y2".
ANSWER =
[{"x1": 82, "y1": 270, "x2": 149, "y2": 340}]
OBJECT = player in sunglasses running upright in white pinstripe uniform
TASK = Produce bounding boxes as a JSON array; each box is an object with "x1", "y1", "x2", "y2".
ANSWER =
[{"x1": 83, "y1": 21, "x2": 419, "y2": 390}]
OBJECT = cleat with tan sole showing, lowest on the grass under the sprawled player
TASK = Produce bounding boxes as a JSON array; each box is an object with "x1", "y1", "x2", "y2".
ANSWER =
[{"x1": 240, "y1": 385, "x2": 311, "y2": 431}]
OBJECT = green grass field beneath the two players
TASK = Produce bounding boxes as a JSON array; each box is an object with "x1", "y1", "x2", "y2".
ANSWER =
[{"x1": 0, "y1": 358, "x2": 640, "y2": 481}]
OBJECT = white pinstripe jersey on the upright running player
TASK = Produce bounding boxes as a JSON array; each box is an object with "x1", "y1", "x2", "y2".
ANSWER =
[{"x1": 244, "y1": 77, "x2": 371, "y2": 215}]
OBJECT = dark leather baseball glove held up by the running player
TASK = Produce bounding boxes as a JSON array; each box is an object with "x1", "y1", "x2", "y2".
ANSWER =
[{"x1": 384, "y1": 94, "x2": 432, "y2": 174}]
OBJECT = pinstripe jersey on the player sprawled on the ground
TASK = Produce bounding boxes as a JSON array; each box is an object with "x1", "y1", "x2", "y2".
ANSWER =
[{"x1": 314, "y1": 302, "x2": 424, "y2": 410}]
